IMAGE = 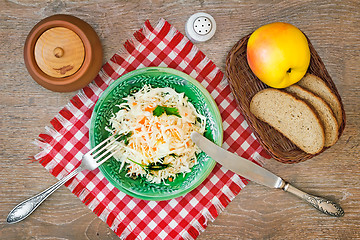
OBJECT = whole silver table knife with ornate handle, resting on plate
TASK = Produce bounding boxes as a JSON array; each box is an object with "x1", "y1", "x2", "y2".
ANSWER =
[{"x1": 191, "y1": 132, "x2": 345, "y2": 217}]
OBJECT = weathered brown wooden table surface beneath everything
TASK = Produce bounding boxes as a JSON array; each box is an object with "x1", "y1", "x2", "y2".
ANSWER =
[{"x1": 0, "y1": 0, "x2": 360, "y2": 240}]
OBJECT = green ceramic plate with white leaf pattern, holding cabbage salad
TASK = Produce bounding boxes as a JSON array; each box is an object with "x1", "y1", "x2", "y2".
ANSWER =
[{"x1": 90, "y1": 67, "x2": 223, "y2": 201}]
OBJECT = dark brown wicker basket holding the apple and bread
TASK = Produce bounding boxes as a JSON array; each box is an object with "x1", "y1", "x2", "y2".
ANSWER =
[{"x1": 226, "y1": 34, "x2": 345, "y2": 163}]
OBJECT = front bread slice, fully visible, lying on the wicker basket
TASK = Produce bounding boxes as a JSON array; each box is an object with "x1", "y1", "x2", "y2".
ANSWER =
[{"x1": 250, "y1": 88, "x2": 325, "y2": 154}]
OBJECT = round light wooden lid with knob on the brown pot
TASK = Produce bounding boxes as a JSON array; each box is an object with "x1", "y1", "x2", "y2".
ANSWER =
[{"x1": 35, "y1": 27, "x2": 85, "y2": 78}]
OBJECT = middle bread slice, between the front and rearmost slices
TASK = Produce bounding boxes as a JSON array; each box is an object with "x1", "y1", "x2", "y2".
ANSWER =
[{"x1": 285, "y1": 85, "x2": 339, "y2": 147}]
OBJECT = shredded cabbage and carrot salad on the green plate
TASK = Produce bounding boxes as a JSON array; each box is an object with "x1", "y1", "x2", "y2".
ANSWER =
[{"x1": 107, "y1": 85, "x2": 206, "y2": 184}]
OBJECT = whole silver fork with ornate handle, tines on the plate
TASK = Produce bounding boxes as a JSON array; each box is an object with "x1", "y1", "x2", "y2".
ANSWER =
[{"x1": 6, "y1": 135, "x2": 120, "y2": 223}]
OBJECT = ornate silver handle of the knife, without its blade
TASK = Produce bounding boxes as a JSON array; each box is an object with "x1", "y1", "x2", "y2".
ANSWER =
[{"x1": 282, "y1": 183, "x2": 345, "y2": 217}]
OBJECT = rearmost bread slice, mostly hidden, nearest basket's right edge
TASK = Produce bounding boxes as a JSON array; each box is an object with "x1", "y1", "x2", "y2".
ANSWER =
[{"x1": 297, "y1": 73, "x2": 342, "y2": 126}]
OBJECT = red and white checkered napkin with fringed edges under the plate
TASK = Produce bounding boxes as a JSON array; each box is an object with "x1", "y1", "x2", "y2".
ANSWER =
[{"x1": 35, "y1": 19, "x2": 269, "y2": 240}]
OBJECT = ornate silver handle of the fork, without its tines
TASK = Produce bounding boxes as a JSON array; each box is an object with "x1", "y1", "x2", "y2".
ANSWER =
[{"x1": 6, "y1": 167, "x2": 82, "y2": 223}]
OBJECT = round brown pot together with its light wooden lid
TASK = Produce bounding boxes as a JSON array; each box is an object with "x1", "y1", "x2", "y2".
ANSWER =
[{"x1": 24, "y1": 14, "x2": 103, "y2": 92}]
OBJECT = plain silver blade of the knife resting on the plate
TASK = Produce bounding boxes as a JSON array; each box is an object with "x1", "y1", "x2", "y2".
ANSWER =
[{"x1": 191, "y1": 132, "x2": 285, "y2": 188}]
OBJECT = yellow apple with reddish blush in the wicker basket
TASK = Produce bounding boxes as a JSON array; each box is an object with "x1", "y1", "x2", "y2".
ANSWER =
[{"x1": 247, "y1": 22, "x2": 310, "y2": 88}]
